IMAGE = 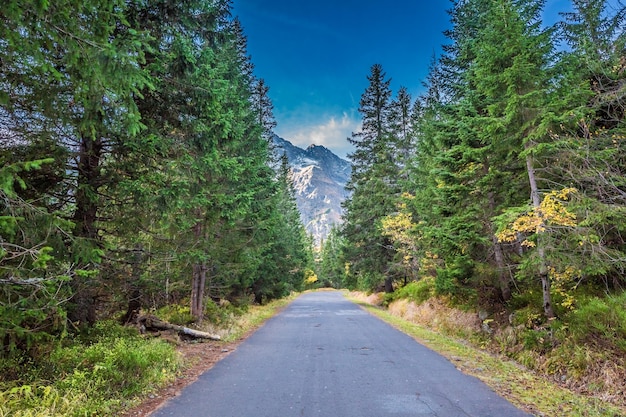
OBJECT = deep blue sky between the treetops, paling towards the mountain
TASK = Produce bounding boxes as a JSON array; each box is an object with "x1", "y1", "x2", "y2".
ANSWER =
[{"x1": 233, "y1": 0, "x2": 570, "y2": 157}]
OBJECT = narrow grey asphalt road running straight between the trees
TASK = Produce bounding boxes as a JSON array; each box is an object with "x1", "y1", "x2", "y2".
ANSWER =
[{"x1": 152, "y1": 292, "x2": 530, "y2": 417}]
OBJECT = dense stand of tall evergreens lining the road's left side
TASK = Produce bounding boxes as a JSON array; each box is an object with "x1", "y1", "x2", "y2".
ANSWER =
[{"x1": 0, "y1": 0, "x2": 312, "y2": 355}]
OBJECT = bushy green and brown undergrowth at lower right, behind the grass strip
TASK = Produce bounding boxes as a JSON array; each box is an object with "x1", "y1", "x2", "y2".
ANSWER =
[{"x1": 490, "y1": 293, "x2": 626, "y2": 406}]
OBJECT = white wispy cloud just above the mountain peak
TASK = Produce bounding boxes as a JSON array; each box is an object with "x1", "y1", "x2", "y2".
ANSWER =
[{"x1": 277, "y1": 113, "x2": 361, "y2": 158}]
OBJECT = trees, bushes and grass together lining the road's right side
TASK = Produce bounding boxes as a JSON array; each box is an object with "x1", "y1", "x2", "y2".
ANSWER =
[{"x1": 316, "y1": 0, "x2": 626, "y2": 416}]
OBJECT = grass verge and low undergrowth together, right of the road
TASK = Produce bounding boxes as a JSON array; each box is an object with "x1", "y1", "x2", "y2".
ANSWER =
[{"x1": 349, "y1": 290, "x2": 626, "y2": 417}]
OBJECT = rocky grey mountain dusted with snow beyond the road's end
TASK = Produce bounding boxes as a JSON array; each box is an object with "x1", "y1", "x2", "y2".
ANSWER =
[{"x1": 273, "y1": 135, "x2": 351, "y2": 244}]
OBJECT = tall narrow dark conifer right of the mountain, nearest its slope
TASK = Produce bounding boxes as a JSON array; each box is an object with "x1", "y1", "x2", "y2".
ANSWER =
[{"x1": 342, "y1": 64, "x2": 399, "y2": 292}]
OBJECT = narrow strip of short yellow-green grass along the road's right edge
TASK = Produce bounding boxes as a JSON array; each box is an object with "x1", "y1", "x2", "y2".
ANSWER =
[{"x1": 355, "y1": 300, "x2": 626, "y2": 417}]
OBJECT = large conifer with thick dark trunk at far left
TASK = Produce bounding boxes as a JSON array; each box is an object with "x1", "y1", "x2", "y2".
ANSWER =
[{"x1": 0, "y1": 0, "x2": 149, "y2": 324}]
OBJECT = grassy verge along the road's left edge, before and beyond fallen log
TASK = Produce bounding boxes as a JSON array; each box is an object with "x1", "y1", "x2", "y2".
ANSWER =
[{"x1": 0, "y1": 295, "x2": 295, "y2": 417}]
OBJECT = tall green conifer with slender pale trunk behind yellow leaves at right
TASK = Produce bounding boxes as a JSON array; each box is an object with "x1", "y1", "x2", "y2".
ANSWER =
[{"x1": 471, "y1": 1, "x2": 555, "y2": 318}]
